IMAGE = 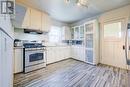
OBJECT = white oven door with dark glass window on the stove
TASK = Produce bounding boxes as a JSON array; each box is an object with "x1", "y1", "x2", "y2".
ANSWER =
[{"x1": 25, "y1": 49, "x2": 45, "y2": 67}]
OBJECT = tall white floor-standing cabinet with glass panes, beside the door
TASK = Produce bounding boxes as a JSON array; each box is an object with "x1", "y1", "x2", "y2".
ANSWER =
[{"x1": 85, "y1": 20, "x2": 99, "y2": 65}]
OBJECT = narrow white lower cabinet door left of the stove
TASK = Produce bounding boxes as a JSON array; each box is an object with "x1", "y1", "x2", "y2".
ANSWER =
[{"x1": 14, "y1": 49, "x2": 23, "y2": 73}]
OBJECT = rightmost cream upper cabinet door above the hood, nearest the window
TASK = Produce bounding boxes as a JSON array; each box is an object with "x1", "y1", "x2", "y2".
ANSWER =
[{"x1": 41, "y1": 13, "x2": 51, "y2": 32}]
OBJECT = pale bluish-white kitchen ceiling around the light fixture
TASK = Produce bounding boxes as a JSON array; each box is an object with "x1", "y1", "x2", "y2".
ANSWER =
[{"x1": 19, "y1": 0, "x2": 130, "y2": 23}]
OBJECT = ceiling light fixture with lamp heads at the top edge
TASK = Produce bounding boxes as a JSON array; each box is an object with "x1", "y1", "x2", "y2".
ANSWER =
[{"x1": 65, "y1": 0, "x2": 88, "y2": 8}]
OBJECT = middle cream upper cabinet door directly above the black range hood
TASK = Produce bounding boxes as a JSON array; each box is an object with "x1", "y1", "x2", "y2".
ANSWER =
[{"x1": 30, "y1": 9, "x2": 42, "y2": 30}]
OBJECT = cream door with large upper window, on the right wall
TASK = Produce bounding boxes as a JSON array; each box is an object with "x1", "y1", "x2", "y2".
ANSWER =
[{"x1": 101, "y1": 19, "x2": 127, "y2": 69}]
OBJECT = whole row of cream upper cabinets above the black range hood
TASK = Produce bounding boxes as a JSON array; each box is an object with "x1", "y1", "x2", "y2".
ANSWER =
[{"x1": 13, "y1": 4, "x2": 51, "y2": 32}]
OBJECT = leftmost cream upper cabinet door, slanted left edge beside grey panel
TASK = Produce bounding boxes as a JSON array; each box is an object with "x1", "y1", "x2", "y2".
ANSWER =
[{"x1": 22, "y1": 8, "x2": 30, "y2": 28}]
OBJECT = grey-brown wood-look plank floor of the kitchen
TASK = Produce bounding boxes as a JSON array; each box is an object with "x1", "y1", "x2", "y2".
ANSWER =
[{"x1": 14, "y1": 59, "x2": 128, "y2": 87}]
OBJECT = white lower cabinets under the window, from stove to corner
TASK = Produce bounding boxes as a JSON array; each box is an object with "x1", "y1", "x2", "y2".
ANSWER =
[{"x1": 47, "y1": 46, "x2": 70, "y2": 64}]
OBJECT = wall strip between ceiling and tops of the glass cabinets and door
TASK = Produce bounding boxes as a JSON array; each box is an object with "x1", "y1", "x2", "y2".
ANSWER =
[{"x1": 69, "y1": 5, "x2": 130, "y2": 26}]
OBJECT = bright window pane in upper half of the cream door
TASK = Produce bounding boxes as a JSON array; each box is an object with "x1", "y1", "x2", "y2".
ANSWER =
[{"x1": 104, "y1": 22, "x2": 121, "y2": 38}]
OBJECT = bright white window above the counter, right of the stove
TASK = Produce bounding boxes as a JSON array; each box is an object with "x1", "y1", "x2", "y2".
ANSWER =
[{"x1": 49, "y1": 26, "x2": 61, "y2": 43}]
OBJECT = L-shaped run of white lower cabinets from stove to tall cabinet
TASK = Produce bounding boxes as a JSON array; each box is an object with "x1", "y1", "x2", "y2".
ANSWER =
[{"x1": 47, "y1": 45, "x2": 85, "y2": 64}]
